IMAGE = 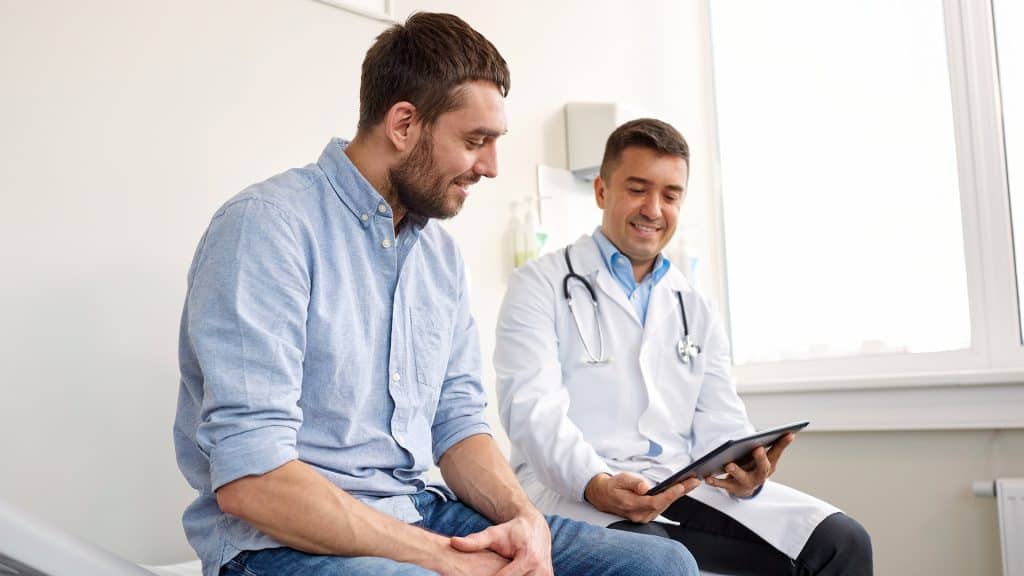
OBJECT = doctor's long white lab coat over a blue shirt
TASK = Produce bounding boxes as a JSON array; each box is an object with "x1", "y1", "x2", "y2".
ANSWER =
[{"x1": 495, "y1": 236, "x2": 839, "y2": 558}]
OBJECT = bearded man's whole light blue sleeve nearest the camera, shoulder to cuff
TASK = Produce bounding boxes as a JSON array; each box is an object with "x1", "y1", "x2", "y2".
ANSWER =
[{"x1": 186, "y1": 199, "x2": 309, "y2": 490}]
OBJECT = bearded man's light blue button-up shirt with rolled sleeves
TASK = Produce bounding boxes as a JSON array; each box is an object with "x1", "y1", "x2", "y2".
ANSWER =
[{"x1": 174, "y1": 139, "x2": 490, "y2": 576}]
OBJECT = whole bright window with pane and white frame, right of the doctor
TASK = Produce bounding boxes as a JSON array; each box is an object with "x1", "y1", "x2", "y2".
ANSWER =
[{"x1": 710, "y1": 0, "x2": 1024, "y2": 399}]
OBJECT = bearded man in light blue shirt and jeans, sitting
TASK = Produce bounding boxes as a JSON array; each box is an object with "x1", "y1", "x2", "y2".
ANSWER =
[{"x1": 174, "y1": 13, "x2": 695, "y2": 576}]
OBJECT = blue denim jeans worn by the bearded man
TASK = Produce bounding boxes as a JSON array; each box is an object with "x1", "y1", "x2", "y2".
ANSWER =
[{"x1": 220, "y1": 492, "x2": 697, "y2": 576}]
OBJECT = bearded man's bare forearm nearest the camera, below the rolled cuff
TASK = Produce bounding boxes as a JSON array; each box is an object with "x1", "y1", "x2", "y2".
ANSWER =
[{"x1": 217, "y1": 460, "x2": 450, "y2": 568}]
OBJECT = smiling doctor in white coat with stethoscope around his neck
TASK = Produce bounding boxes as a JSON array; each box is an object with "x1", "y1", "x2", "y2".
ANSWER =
[{"x1": 495, "y1": 119, "x2": 871, "y2": 576}]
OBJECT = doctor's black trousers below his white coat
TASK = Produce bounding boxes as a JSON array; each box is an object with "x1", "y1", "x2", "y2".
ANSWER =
[{"x1": 608, "y1": 496, "x2": 872, "y2": 576}]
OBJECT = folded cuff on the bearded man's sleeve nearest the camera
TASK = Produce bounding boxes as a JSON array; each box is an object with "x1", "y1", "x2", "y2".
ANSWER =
[{"x1": 210, "y1": 426, "x2": 299, "y2": 490}]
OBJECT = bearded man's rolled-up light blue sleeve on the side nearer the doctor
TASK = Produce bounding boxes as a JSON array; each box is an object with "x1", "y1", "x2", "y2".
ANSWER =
[{"x1": 431, "y1": 260, "x2": 492, "y2": 463}]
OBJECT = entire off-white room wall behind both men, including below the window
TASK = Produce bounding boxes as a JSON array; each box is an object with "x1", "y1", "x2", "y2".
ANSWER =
[{"x1": 0, "y1": 0, "x2": 1024, "y2": 575}]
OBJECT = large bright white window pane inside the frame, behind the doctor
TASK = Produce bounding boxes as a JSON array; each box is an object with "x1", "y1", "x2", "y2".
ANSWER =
[{"x1": 712, "y1": 0, "x2": 971, "y2": 364}]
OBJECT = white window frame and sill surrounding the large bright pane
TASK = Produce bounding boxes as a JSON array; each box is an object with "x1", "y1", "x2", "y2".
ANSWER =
[{"x1": 701, "y1": 0, "x2": 1024, "y2": 429}]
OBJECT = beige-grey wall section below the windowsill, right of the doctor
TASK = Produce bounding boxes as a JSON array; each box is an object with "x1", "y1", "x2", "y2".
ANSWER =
[{"x1": 775, "y1": 428, "x2": 1024, "y2": 576}]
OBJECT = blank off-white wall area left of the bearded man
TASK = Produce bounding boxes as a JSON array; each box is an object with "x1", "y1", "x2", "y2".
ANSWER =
[{"x1": 0, "y1": 0, "x2": 381, "y2": 562}]
